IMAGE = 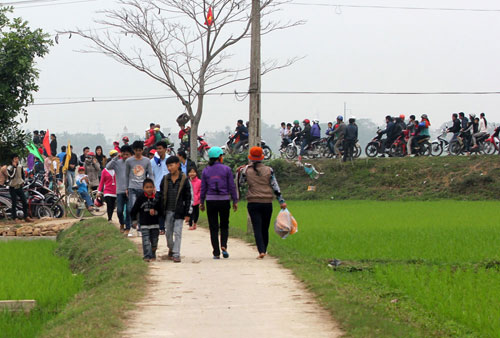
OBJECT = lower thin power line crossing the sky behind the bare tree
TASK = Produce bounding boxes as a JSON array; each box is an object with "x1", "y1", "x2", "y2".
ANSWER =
[{"x1": 31, "y1": 91, "x2": 500, "y2": 106}]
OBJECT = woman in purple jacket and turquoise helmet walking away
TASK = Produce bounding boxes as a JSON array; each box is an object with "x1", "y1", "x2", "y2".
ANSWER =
[{"x1": 200, "y1": 147, "x2": 238, "y2": 259}]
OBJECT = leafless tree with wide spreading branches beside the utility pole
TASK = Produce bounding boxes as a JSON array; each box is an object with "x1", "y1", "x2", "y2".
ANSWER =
[{"x1": 65, "y1": 0, "x2": 302, "y2": 160}]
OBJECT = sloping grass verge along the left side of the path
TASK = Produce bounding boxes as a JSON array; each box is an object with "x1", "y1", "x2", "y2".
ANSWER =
[{"x1": 41, "y1": 218, "x2": 147, "y2": 337}]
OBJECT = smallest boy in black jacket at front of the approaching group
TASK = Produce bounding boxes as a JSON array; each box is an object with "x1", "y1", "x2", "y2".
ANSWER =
[{"x1": 130, "y1": 178, "x2": 165, "y2": 262}]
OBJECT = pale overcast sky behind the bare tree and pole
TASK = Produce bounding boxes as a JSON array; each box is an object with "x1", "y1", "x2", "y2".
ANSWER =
[{"x1": 10, "y1": 0, "x2": 500, "y2": 137}]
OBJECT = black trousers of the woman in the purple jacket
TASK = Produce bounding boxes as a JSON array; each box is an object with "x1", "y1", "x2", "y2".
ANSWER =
[{"x1": 207, "y1": 200, "x2": 231, "y2": 256}]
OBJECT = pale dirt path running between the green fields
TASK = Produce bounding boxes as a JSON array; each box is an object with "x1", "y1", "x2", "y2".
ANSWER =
[{"x1": 122, "y1": 224, "x2": 341, "y2": 338}]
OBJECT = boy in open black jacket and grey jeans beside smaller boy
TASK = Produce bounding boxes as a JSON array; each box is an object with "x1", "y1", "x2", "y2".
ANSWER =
[{"x1": 160, "y1": 156, "x2": 193, "y2": 263}]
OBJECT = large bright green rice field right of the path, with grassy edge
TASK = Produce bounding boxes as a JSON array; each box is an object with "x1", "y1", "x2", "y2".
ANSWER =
[{"x1": 221, "y1": 200, "x2": 500, "y2": 337}]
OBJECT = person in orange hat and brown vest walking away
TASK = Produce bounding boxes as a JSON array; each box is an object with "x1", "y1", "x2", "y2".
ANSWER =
[{"x1": 238, "y1": 147, "x2": 286, "y2": 259}]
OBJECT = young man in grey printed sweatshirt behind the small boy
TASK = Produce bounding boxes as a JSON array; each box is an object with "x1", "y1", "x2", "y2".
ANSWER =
[{"x1": 125, "y1": 141, "x2": 154, "y2": 235}]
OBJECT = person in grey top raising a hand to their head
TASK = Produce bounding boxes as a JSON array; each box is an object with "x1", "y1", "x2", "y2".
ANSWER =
[{"x1": 106, "y1": 145, "x2": 132, "y2": 235}]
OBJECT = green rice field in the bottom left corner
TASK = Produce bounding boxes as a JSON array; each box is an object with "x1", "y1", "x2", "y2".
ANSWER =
[{"x1": 0, "y1": 240, "x2": 83, "y2": 338}]
